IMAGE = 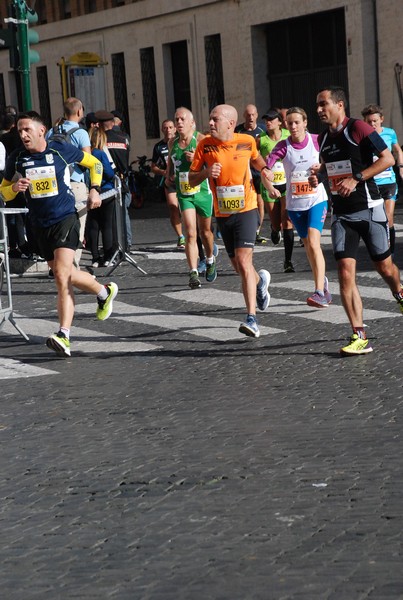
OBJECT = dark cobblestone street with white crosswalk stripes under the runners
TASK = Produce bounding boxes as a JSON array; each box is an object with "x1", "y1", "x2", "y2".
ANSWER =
[{"x1": 0, "y1": 205, "x2": 403, "y2": 600}]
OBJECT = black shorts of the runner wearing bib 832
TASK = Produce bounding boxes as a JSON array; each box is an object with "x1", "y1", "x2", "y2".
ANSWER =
[{"x1": 32, "y1": 213, "x2": 80, "y2": 260}]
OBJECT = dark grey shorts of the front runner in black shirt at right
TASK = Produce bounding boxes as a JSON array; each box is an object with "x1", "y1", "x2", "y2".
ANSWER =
[{"x1": 331, "y1": 203, "x2": 391, "y2": 262}]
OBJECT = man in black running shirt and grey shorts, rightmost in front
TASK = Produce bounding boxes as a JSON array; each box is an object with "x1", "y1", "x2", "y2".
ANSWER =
[{"x1": 310, "y1": 87, "x2": 403, "y2": 355}]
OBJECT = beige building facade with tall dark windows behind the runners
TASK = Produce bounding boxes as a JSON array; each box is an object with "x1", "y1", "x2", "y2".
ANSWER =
[{"x1": 0, "y1": 0, "x2": 403, "y2": 157}]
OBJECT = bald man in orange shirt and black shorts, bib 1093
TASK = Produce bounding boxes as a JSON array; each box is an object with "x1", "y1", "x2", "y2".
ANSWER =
[{"x1": 189, "y1": 104, "x2": 270, "y2": 337}]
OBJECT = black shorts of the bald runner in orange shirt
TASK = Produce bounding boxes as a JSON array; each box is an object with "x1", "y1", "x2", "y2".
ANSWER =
[{"x1": 216, "y1": 208, "x2": 260, "y2": 258}]
